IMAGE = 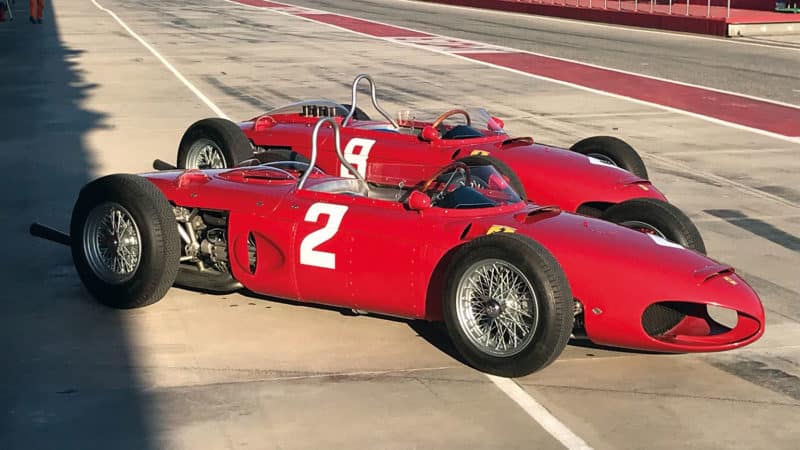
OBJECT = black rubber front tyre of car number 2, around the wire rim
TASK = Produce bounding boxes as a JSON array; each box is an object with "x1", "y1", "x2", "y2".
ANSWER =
[{"x1": 443, "y1": 233, "x2": 574, "y2": 377}]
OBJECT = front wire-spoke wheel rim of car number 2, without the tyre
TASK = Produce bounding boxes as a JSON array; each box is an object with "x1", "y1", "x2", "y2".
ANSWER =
[{"x1": 456, "y1": 259, "x2": 539, "y2": 357}]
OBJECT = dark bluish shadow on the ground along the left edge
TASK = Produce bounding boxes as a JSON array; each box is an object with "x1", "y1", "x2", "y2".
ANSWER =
[{"x1": 0, "y1": 4, "x2": 154, "y2": 450}]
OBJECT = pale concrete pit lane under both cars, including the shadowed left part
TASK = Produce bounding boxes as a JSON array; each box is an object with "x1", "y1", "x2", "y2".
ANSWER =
[{"x1": 0, "y1": 0, "x2": 800, "y2": 449}]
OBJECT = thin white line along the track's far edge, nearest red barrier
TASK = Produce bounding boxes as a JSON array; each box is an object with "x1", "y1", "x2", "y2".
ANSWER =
[{"x1": 394, "y1": 0, "x2": 800, "y2": 51}]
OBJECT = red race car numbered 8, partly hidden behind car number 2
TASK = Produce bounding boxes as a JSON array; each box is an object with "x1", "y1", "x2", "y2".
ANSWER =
[{"x1": 177, "y1": 75, "x2": 705, "y2": 253}]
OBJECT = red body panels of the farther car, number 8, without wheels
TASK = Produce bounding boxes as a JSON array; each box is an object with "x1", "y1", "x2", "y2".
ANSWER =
[{"x1": 240, "y1": 113, "x2": 666, "y2": 212}]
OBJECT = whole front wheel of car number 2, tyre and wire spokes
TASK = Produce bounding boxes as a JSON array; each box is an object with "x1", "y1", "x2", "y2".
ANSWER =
[{"x1": 443, "y1": 233, "x2": 573, "y2": 377}]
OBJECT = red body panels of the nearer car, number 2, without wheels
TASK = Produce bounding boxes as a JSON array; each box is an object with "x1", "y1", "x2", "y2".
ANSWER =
[{"x1": 143, "y1": 166, "x2": 764, "y2": 352}]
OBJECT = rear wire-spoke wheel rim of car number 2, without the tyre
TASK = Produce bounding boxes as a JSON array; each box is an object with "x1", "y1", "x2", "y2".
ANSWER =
[{"x1": 83, "y1": 202, "x2": 142, "y2": 284}]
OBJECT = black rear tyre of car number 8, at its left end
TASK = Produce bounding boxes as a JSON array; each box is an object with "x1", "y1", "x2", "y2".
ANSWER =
[{"x1": 177, "y1": 117, "x2": 253, "y2": 169}]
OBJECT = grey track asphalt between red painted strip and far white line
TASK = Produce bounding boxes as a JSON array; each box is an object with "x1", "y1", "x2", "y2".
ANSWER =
[{"x1": 286, "y1": 0, "x2": 800, "y2": 105}]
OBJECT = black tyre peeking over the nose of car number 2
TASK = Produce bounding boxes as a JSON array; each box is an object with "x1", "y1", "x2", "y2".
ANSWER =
[{"x1": 600, "y1": 198, "x2": 706, "y2": 254}]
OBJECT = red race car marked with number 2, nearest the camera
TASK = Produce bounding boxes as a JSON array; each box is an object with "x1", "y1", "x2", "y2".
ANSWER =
[{"x1": 31, "y1": 118, "x2": 764, "y2": 376}]
